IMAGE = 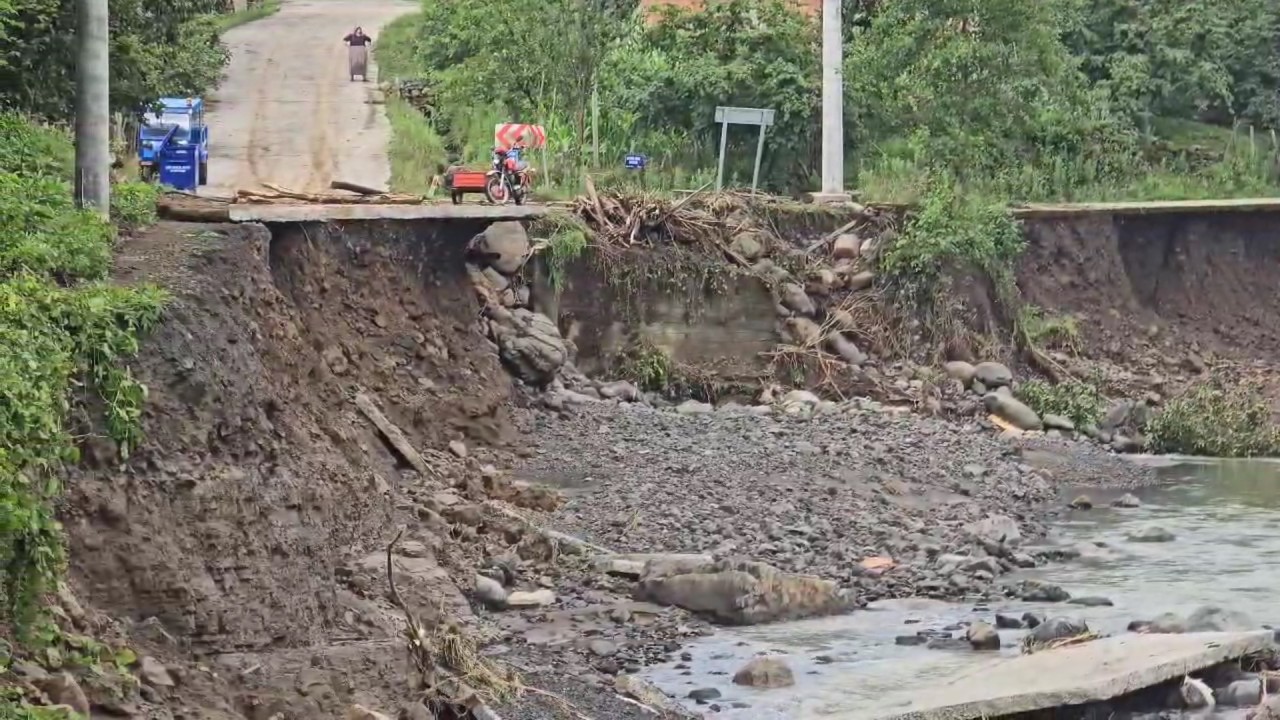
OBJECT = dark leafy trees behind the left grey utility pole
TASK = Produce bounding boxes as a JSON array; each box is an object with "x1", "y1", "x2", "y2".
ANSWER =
[{"x1": 0, "y1": 0, "x2": 229, "y2": 119}]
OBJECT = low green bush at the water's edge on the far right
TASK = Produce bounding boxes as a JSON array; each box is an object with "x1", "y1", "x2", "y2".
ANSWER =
[{"x1": 1147, "y1": 383, "x2": 1280, "y2": 457}]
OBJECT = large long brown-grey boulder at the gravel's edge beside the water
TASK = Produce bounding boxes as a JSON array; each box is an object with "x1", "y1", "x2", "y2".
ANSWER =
[{"x1": 636, "y1": 560, "x2": 858, "y2": 625}]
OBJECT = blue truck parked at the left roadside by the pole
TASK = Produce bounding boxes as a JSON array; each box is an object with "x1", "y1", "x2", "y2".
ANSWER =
[{"x1": 138, "y1": 97, "x2": 209, "y2": 192}]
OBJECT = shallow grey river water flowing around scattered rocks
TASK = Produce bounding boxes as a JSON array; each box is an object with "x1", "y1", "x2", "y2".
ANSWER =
[{"x1": 646, "y1": 457, "x2": 1280, "y2": 720}]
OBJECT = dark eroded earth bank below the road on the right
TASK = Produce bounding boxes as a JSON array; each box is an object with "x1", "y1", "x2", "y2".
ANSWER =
[{"x1": 1018, "y1": 213, "x2": 1280, "y2": 359}]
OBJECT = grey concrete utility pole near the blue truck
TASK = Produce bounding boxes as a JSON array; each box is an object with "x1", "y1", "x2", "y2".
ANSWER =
[{"x1": 76, "y1": 0, "x2": 111, "y2": 215}]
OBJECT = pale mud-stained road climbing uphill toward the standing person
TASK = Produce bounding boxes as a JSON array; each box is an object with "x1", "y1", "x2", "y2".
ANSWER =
[{"x1": 202, "y1": 0, "x2": 417, "y2": 195}]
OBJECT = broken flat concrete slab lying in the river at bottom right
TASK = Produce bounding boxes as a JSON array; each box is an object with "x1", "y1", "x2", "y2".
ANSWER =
[{"x1": 844, "y1": 630, "x2": 1275, "y2": 720}]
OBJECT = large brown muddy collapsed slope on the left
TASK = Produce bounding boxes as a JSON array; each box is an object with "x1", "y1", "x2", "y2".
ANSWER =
[{"x1": 64, "y1": 223, "x2": 511, "y2": 717}]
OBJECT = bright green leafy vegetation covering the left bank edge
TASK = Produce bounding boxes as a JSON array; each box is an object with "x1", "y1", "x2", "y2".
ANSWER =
[{"x1": 0, "y1": 115, "x2": 165, "y2": 641}]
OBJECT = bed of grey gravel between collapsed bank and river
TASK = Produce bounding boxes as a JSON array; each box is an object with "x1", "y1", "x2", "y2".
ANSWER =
[{"x1": 518, "y1": 401, "x2": 1153, "y2": 601}]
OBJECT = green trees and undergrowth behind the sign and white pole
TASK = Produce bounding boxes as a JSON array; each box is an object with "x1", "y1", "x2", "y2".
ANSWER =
[{"x1": 378, "y1": 0, "x2": 1280, "y2": 202}]
